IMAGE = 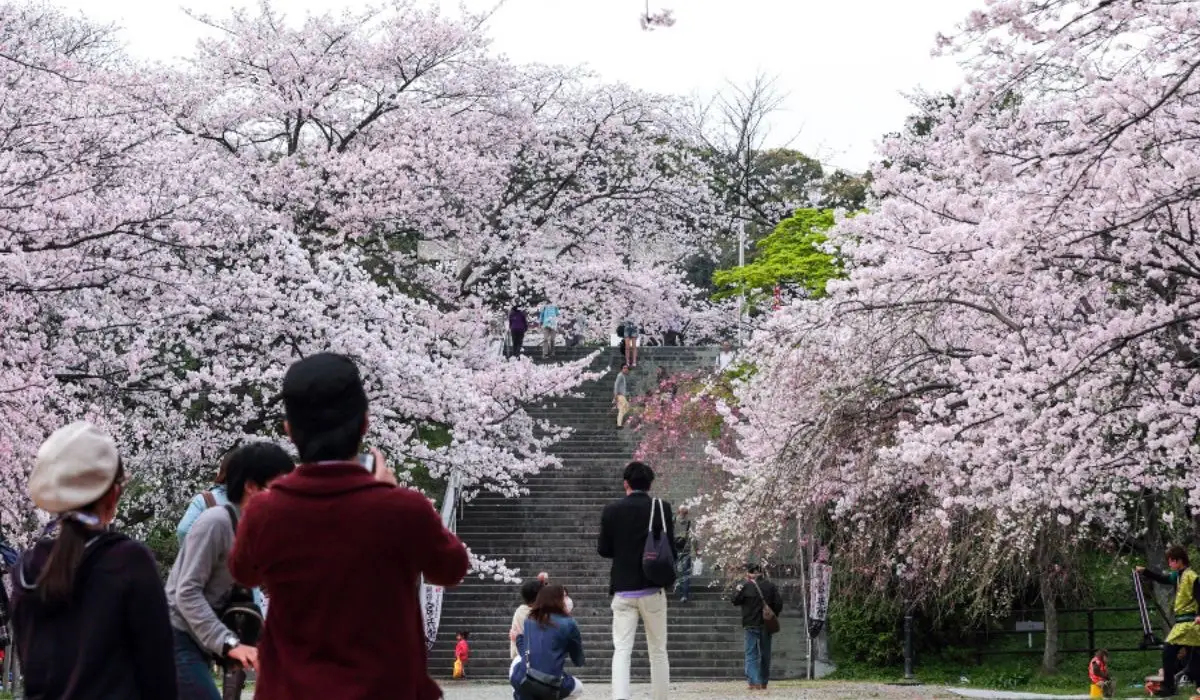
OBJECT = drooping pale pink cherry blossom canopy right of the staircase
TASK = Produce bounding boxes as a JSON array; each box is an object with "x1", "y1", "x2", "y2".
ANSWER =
[{"x1": 709, "y1": 0, "x2": 1200, "y2": 665}]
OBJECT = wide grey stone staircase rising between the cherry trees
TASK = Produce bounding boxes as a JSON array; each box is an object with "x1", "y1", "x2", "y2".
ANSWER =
[{"x1": 430, "y1": 347, "x2": 743, "y2": 681}]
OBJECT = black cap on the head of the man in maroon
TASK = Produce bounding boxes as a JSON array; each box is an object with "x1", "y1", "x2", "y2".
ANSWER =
[{"x1": 282, "y1": 353, "x2": 367, "y2": 432}]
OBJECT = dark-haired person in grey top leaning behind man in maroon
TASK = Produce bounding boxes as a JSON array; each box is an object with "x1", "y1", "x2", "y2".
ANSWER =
[{"x1": 167, "y1": 442, "x2": 295, "y2": 700}]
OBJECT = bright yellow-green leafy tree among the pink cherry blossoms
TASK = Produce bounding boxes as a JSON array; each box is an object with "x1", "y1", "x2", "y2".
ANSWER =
[{"x1": 713, "y1": 209, "x2": 844, "y2": 304}]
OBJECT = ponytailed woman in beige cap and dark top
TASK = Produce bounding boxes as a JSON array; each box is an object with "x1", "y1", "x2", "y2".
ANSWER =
[{"x1": 12, "y1": 423, "x2": 176, "y2": 700}]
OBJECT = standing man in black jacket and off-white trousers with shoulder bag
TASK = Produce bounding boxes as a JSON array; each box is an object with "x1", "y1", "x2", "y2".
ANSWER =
[{"x1": 596, "y1": 462, "x2": 678, "y2": 700}]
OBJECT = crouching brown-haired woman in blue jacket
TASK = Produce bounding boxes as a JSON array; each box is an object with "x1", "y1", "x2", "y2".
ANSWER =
[{"x1": 509, "y1": 584, "x2": 583, "y2": 700}]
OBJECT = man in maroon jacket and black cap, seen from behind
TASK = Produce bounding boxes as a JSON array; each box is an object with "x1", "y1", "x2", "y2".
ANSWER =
[{"x1": 229, "y1": 353, "x2": 467, "y2": 700}]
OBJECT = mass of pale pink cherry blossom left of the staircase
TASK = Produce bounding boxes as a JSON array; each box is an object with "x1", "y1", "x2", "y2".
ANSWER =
[{"x1": 0, "y1": 2, "x2": 713, "y2": 559}]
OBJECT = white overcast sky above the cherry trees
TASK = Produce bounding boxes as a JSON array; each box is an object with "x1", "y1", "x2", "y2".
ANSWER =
[{"x1": 52, "y1": 0, "x2": 982, "y2": 170}]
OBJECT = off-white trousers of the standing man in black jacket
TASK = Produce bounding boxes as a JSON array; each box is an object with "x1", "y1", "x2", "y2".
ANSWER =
[{"x1": 612, "y1": 591, "x2": 671, "y2": 700}]
